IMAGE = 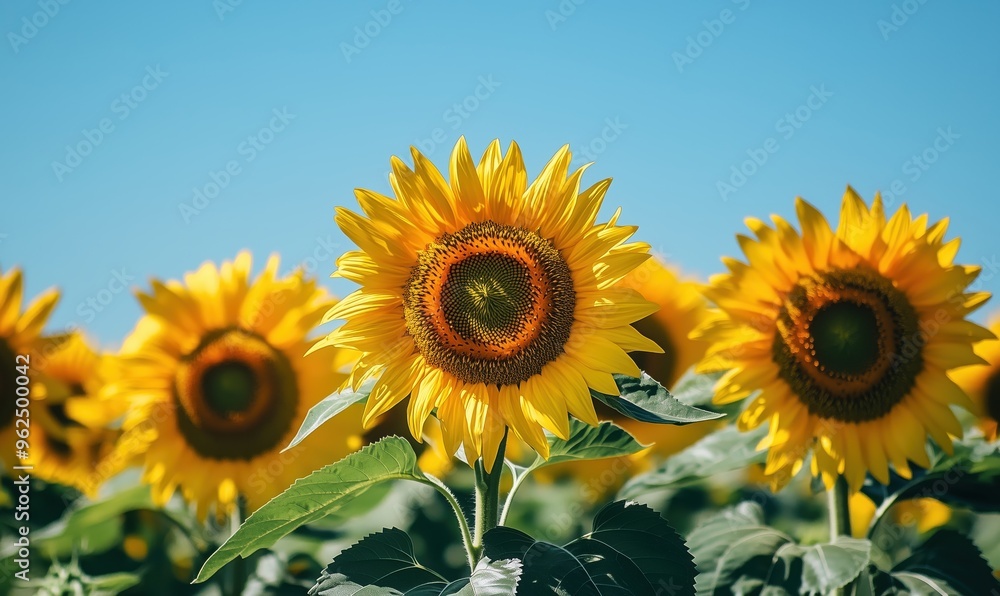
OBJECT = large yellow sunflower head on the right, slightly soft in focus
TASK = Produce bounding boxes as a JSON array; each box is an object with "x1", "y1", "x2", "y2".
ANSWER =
[{"x1": 695, "y1": 187, "x2": 993, "y2": 490}]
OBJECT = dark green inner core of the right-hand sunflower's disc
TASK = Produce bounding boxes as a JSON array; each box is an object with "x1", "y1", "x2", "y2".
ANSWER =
[{"x1": 809, "y1": 301, "x2": 879, "y2": 375}]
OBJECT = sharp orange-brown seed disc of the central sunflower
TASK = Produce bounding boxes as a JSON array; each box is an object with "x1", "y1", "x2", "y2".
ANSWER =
[{"x1": 403, "y1": 221, "x2": 576, "y2": 385}]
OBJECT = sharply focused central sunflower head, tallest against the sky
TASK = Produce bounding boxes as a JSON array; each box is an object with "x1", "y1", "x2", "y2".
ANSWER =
[{"x1": 315, "y1": 139, "x2": 659, "y2": 470}]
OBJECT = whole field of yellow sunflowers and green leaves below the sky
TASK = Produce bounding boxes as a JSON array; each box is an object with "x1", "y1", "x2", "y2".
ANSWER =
[{"x1": 0, "y1": 139, "x2": 1000, "y2": 596}]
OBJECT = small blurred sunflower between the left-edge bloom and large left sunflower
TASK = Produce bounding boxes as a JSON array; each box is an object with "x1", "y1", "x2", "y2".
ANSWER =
[{"x1": 29, "y1": 333, "x2": 120, "y2": 497}]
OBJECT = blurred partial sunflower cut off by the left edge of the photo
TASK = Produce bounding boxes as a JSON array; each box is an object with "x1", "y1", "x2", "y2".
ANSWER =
[{"x1": 0, "y1": 268, "x2": 59, "y2": 467}]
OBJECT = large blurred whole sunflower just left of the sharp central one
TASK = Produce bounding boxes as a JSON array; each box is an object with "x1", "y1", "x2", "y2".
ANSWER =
[{"x1": 106, "y1": 252, "x2": 361, "y2": 519}]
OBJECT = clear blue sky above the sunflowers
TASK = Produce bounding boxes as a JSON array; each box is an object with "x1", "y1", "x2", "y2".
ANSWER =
[{"x1": 0, "y1": 0, "x2": 1000, "y2": 347}]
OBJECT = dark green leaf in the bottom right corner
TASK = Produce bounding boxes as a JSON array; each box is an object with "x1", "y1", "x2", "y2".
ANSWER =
[{"x1": 892, "y1": 530, "x2": 1000, "y2": 594}]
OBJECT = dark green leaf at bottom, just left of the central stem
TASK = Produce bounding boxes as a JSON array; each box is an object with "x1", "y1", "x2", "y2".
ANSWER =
[{"x1": 326, "y1": 528, "x2": 446, "y2": 591}]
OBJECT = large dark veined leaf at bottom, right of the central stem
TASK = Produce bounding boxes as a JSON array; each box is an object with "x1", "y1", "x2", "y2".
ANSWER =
[{"x1": 483, "y1": 501, "x2": 695, "y2": 596}]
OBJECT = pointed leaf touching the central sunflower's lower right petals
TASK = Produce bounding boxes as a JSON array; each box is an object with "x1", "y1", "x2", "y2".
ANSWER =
[{"x1": 590, "y1": 373, "x2": 725, "y2": 424}]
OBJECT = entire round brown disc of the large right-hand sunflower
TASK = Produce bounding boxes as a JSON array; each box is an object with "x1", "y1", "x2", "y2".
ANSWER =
[{"x1": 773, "y1": 268, "x2": 923, "y2": 422}]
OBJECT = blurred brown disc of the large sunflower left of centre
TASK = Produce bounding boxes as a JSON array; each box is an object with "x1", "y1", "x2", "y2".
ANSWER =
[{"x1": 174, "y1": 328, "x2": 298, "y2": 459}]
